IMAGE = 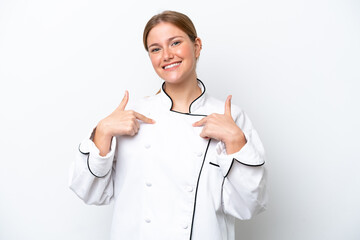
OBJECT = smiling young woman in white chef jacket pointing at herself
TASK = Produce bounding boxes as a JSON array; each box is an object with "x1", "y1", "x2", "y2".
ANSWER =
[{"x1": 70, "y1": 11, "x2": 266, "y2": 240}]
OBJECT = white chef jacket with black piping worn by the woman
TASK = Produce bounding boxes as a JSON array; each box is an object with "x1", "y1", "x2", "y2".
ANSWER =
[{"x1": 70, "y1": 80, "x2": 267, "y2": 240}]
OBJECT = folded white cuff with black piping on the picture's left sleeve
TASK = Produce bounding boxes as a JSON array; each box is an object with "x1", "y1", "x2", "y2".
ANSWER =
[{"x1": 79, "y1": 132, "x2": 116, "y2": 178}]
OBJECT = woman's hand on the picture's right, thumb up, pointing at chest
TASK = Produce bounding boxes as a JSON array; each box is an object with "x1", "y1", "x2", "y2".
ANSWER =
[{"x1": 193, "y1": 95, "x2": 246, "y2": 154}]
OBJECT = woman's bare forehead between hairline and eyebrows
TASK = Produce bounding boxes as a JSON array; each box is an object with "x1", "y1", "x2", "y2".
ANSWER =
[{"x1": 147, "y1": 22, "x2": 187, "y2": 45}]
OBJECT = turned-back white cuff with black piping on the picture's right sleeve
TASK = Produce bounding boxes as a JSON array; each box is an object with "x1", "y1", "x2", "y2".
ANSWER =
[{"x1": 216, "y1": 141, "x2": 265, "y2": 177}]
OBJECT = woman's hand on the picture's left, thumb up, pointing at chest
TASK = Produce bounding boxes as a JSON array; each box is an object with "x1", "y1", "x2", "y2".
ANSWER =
[{"x1": 93, "y1": 91, "x2": 155, "y2": 156}]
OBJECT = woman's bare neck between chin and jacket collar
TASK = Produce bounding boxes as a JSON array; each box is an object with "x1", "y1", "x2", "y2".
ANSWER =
[{"x1": 164, "y1": 77, "x2": 201, "y2": 113}]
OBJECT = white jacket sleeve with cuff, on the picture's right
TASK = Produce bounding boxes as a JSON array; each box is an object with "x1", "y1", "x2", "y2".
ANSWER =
[{"x1": 216, "y1": 111, "x2": 267, "y2": 220}]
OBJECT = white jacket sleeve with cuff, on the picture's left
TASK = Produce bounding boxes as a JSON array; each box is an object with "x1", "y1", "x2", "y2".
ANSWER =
[{"x1": 69, "y1": 128, "x2": 116, "y2": 205}]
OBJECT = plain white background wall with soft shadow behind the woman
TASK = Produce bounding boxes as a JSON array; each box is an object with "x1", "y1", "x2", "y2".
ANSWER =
[{"x1": 0, "y1": 0, "x2": 360, "y2": 240}]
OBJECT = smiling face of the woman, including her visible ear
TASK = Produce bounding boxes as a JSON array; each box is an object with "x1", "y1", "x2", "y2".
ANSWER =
[{"x1": 147, "y1": 22, "x2": 201, "y2": 84}]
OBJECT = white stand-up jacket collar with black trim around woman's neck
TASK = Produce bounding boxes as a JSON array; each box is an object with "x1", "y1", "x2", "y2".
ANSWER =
[{"x1": 160, "y1": 79, "x2": 206, "y2": 114}]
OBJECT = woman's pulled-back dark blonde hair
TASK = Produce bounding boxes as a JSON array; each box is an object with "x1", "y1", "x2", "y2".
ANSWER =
[{"x1": 143, "y1": 11, "x2": 197, "y2": 51}]
